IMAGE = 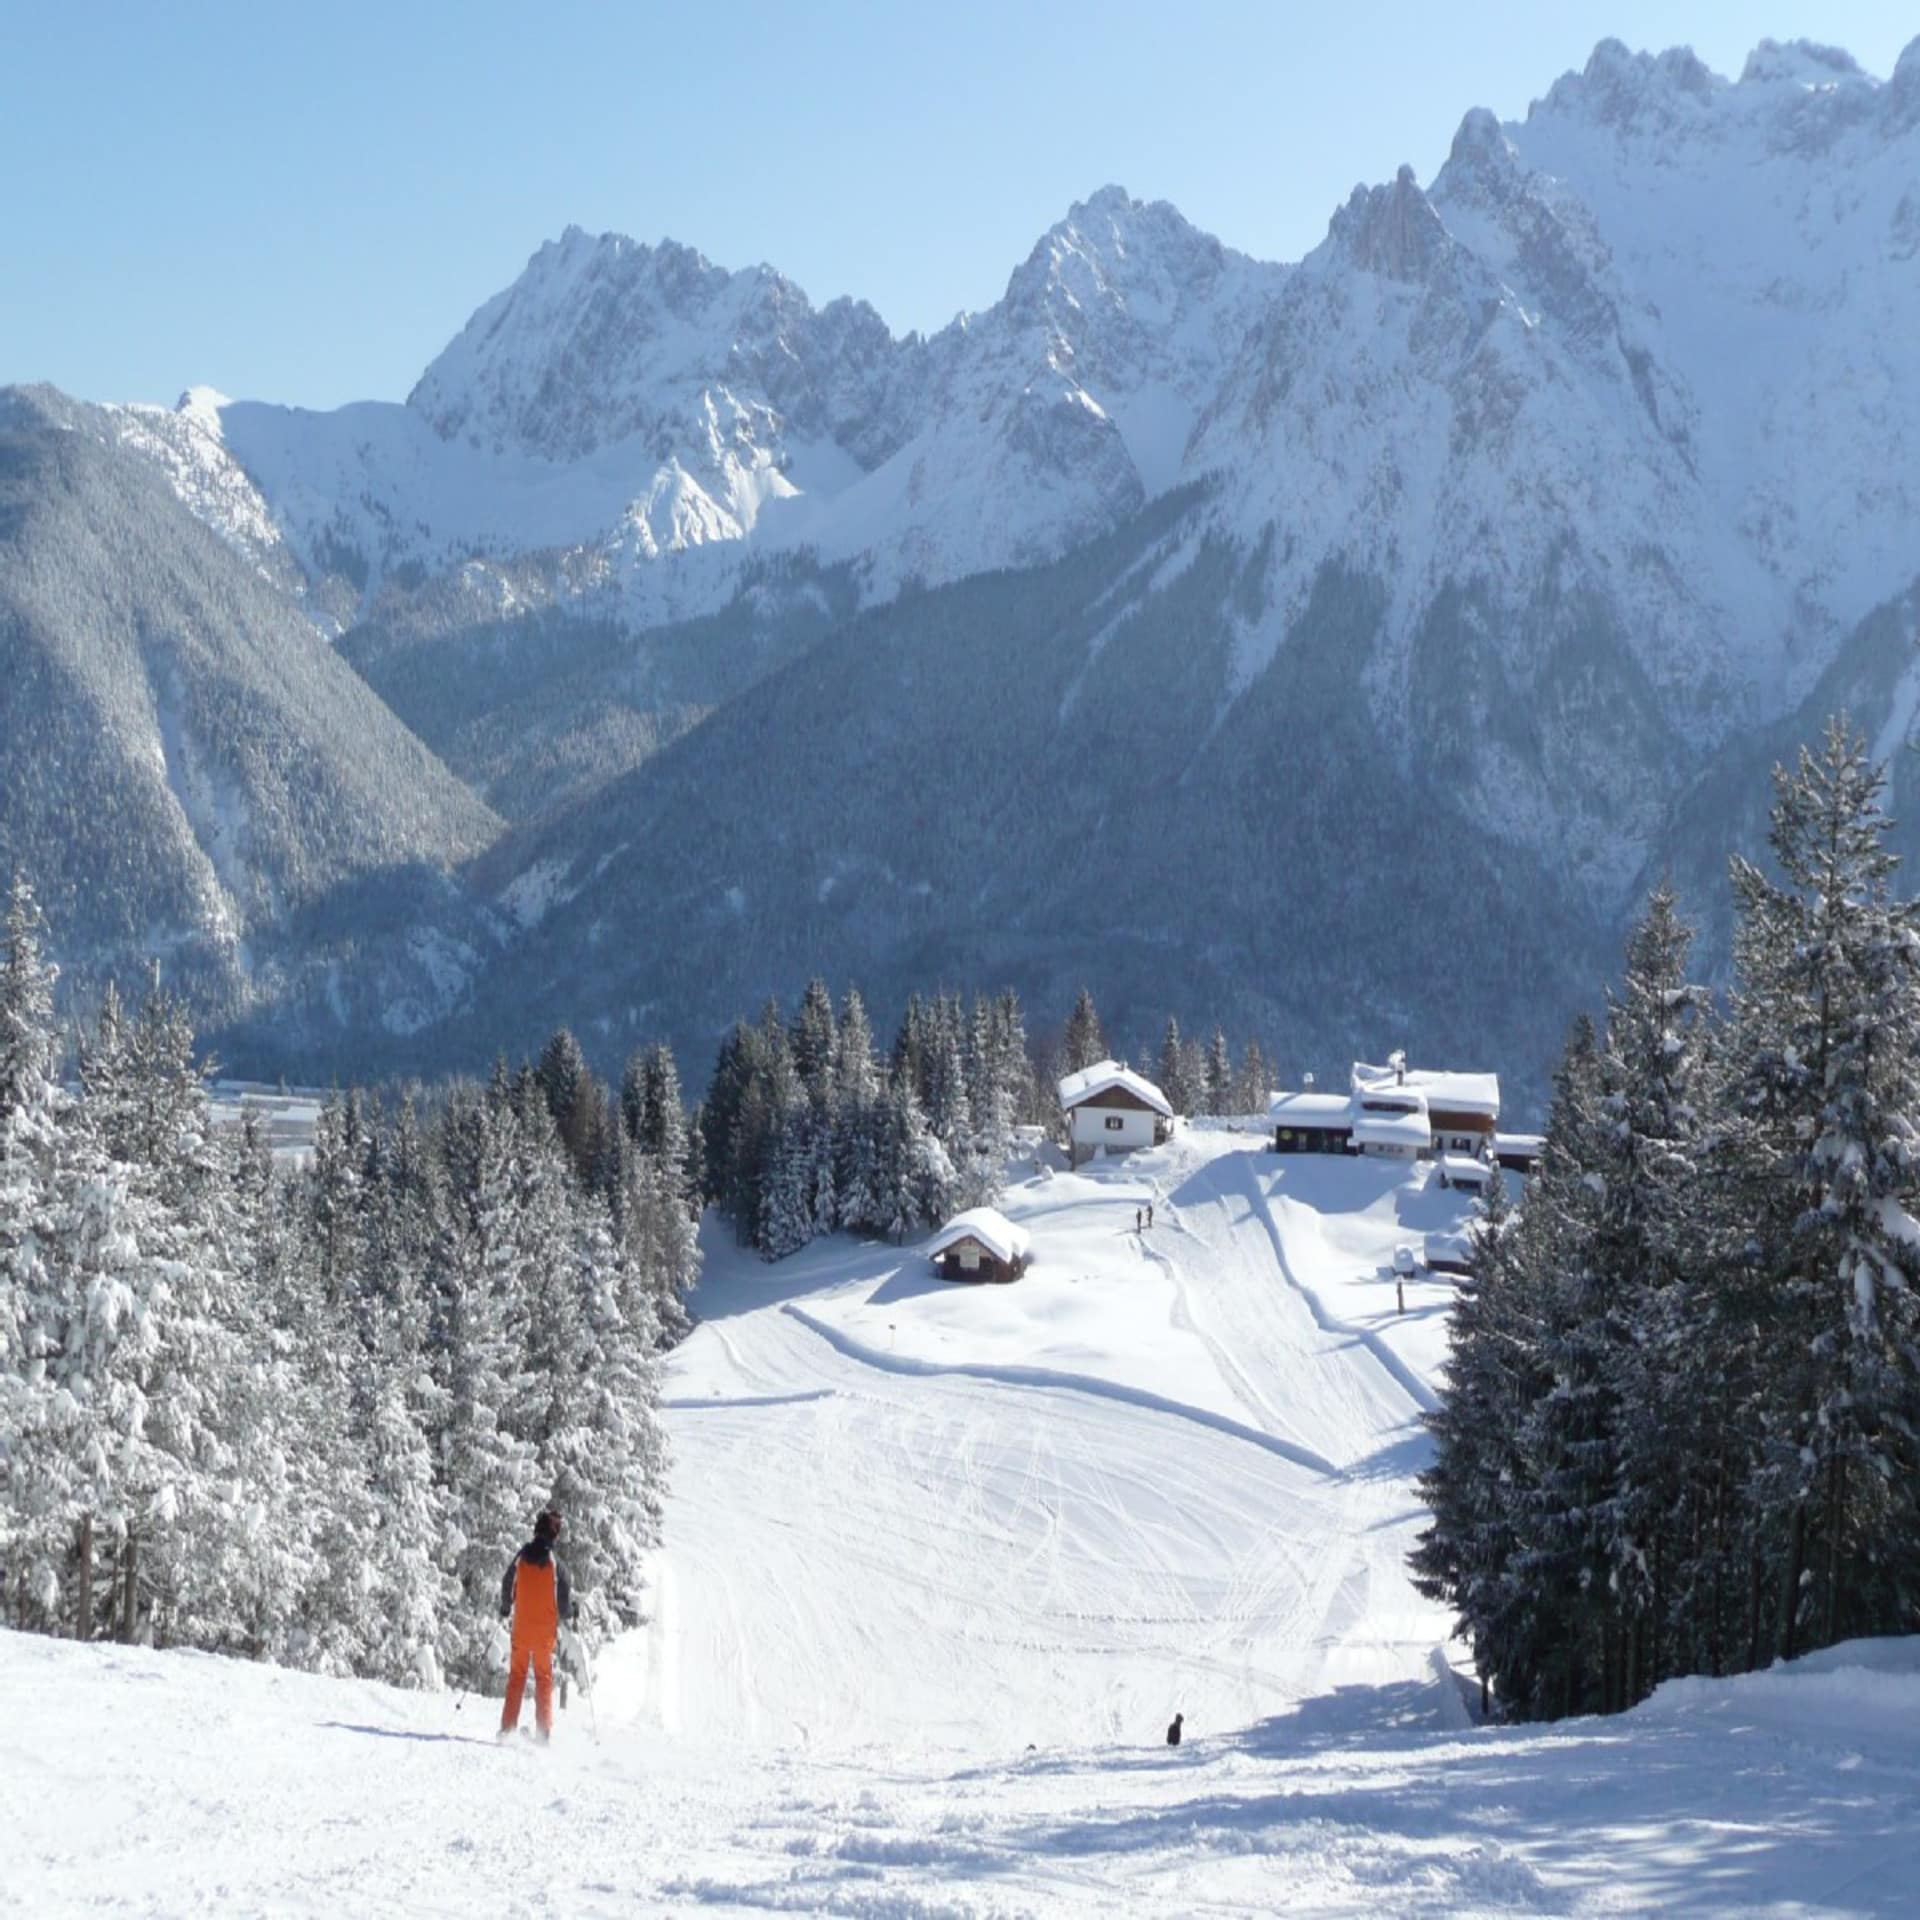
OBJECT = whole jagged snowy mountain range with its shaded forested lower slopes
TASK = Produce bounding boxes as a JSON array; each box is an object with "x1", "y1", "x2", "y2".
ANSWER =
[{"x1": 0, "y1": 40, "x2": 1920, "y2": 1082}]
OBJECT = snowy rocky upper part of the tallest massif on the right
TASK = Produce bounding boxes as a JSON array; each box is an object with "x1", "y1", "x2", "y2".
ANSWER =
[{"x1": 1196, "y1": 42, "x2": 1920, "y2": 741}]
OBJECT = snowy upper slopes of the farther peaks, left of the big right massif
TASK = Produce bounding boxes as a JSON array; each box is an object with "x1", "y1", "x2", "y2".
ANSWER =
[{"x1": 120, "y1": 188, "x2": 1284, "y2": 606}]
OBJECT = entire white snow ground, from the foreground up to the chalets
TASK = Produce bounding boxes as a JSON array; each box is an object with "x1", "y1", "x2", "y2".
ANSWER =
[{"x1": 15, "y1": 1131, "x2": 1920, "y2": 1916}]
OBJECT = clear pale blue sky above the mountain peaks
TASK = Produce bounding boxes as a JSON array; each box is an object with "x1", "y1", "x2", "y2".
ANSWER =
[{"x1": 0, "y1": 0, "x2": 1920, "y2": 405}]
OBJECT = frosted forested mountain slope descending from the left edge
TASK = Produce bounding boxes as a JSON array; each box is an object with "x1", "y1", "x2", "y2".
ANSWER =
[{"x1": 0, "y1": 392, "x2": 497, "y2": 1036}]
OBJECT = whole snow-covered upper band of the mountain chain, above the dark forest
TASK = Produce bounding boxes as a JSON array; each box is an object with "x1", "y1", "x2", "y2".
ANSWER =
[{"x1": 105, "y1": 40, "x2": 1920, "y2": 741}]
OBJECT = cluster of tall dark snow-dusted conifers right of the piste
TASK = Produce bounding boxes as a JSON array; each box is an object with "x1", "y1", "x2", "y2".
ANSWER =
[{"x1": 1413, "y1": 720, "x2": 1920, "y2": 1718}]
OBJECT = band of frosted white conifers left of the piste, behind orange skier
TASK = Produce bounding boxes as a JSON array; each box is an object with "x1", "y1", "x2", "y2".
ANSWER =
[{"x1": 0, "y1": 887, "x2": 697, "y2": 1686}]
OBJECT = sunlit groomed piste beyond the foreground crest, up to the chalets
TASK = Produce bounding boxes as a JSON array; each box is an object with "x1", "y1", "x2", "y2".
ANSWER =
[{"x1": 620, "y1": 1131, "x2": 1459, "y2": 1759}]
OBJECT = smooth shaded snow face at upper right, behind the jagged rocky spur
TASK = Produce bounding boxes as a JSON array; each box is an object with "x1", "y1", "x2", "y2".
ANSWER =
[{"x1": 1494, "y1": 40, "x2": 1920, "y2": 706}]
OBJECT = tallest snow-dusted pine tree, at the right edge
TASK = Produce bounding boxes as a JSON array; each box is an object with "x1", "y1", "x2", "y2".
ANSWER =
[{"x1": 1728, "y1": 718, "x2": 1920, "y2": 1657}]
